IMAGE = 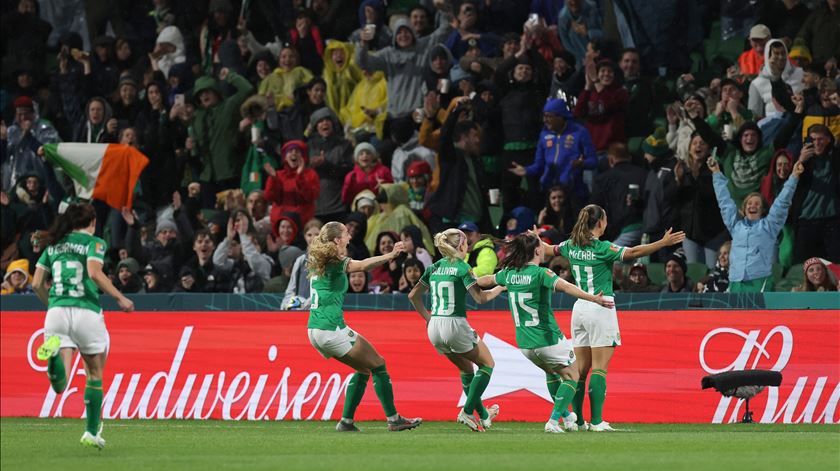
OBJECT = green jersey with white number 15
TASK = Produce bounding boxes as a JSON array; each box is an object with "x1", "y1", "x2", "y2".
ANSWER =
[{"x1": 495, "y1": 264, "x2": 565, "y2": 348}]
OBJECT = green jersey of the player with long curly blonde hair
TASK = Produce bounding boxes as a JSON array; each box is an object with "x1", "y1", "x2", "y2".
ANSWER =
[{"x1": 306, "y1": 258, "x2": 350, "y2": 330}]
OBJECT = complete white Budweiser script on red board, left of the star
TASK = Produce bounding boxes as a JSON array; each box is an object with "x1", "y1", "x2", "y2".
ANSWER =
[{"x1": 27, "y1": 326, "x2": 352, "y2": 420}]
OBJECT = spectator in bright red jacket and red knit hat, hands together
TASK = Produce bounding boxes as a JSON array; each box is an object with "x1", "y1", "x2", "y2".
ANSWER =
[{"x1": 265, "y1": 141, "x2": 321, "y2": 227}]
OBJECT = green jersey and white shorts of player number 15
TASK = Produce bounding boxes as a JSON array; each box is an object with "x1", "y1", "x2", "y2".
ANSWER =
[{"x1": 495, "y1": 264, "x2": 575, "y2": 368}]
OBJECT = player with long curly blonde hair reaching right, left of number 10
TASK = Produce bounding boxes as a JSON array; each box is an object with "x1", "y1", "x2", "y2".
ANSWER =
[{"x1": 306, "y1": 222, "x2": 423, "y2": 432}]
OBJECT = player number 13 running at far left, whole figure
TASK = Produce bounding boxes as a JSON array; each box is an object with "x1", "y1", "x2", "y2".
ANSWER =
[{"x1": 33, "y1": 204, "x2": 134, "y2": 449}]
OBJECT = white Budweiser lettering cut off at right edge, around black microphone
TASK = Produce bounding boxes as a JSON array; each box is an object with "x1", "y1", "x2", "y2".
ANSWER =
[{"x1": 699, "y1": 326, "x2": 840, "y2": 424}]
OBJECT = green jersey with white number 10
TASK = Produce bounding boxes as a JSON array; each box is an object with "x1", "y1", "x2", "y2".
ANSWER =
[{"x1": 420, "y1": 258, "x2": 476, "y2": 317}]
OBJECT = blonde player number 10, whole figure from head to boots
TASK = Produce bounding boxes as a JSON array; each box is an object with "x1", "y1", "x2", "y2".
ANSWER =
[{"x1": 408, "y1": 229, "x2": 504, "y2": 432}]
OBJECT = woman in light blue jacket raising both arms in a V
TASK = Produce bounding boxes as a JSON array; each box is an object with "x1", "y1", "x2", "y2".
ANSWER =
[{"x1": 708, "y1": 152, "x2": 805, "y2": 293}]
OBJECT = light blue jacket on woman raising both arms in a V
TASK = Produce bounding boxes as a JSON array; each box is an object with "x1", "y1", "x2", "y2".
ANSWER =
[{"x1": 712, "y1": 172, "x2": 799, "y2": 282}]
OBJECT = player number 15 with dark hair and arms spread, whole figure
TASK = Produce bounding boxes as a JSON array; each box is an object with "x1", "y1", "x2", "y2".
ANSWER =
[{"x1": 479, "y1": 233, "x2": 615, "y2": 433}]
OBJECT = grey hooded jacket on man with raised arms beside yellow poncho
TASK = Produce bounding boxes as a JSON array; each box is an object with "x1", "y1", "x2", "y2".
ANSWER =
[{"x1": 356, "y1": 18, "x2": 452, "y2": 116}]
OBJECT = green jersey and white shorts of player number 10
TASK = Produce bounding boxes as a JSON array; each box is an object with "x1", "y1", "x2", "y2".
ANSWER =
[{"x1": 420, "y1": 258, "x2": 479, "y2": 354}]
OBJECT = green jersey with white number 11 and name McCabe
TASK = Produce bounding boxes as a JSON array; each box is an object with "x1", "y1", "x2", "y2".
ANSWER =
[{"x1": 560, "y1": 239, "x2": 626, "y2": 296}]
